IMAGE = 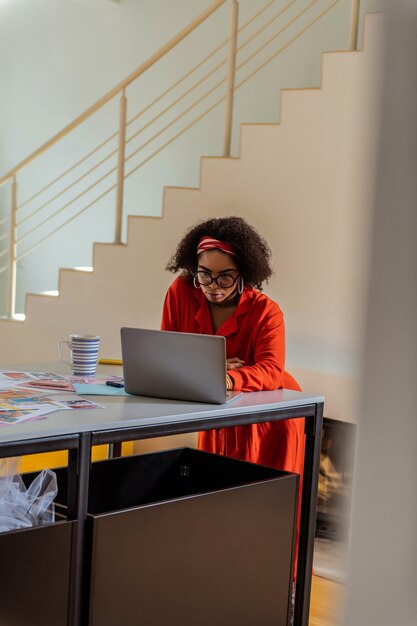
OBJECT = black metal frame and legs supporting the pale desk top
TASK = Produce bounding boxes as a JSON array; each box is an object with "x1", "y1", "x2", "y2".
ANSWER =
[{"x1": 0, "y1": 402, "x2": 323, "y2": 626}]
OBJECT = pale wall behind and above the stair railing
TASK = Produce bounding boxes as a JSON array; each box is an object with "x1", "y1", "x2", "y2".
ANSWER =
[{"x1": 0, "y1": 0, "x2": 382, "y2": 313}]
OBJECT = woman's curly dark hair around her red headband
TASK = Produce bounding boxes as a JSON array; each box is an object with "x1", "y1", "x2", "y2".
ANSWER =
[{"x1": 166, "y1": 216, "x2": 272, "y2": 290}]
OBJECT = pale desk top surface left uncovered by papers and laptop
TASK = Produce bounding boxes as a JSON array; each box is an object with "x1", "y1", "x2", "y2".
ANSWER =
[{"x1": 0, "y1": 363, "x2": 324, "y2": 444}]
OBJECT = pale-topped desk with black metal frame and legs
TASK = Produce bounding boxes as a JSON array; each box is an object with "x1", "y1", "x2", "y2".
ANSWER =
[{"x1": 0, "y1": 363, "x2": 324, "y2": 626}]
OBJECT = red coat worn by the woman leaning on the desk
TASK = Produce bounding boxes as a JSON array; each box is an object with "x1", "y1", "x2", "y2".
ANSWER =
[{"x1": 161, "y1": 278, "x2": 304, "y2": 474}]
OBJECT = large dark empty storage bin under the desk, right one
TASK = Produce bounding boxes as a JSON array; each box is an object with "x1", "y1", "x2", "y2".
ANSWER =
[{"x1": 85, "y1": 448, "x2": 298, "y2": 626}]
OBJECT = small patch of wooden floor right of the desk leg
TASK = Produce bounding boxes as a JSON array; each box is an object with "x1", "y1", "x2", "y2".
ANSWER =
[{"x1": 309, "y1": 576, "x2": 344, "y2": 626}]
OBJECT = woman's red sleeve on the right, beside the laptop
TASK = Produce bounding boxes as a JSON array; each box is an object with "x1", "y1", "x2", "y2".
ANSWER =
[{"x1": 228, "y1": 301, "x2": 285, "y2": 391}]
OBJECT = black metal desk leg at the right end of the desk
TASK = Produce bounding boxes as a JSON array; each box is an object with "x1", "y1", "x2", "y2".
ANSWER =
[{"x1": 294, "y1": 403, "x2": 323, "y2": 626}]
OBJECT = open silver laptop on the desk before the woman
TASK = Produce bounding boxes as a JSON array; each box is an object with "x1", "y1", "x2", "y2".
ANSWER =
[{"x1": 120, "y1": 328, "x2": 241, "y2": 404}]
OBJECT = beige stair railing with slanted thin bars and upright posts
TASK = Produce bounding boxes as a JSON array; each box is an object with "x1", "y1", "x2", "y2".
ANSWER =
[{"x1": 0, "y1": 0, "x2": 360, "y2": 318}]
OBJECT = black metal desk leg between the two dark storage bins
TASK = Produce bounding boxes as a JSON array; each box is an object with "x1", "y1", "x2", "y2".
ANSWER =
[{"x1": 68, "y1": 433, "x2": 91, "y2": 626}]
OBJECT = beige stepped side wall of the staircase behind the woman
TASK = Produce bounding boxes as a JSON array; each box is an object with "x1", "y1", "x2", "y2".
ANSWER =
[{"x1": 0, "y1": 7, "x2": 383, "y2": 420}]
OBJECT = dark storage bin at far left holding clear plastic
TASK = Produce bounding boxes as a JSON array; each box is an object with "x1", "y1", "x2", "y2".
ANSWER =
[{"x1": 0, "y1": 474, "x2": 76, "y2": 626}]
